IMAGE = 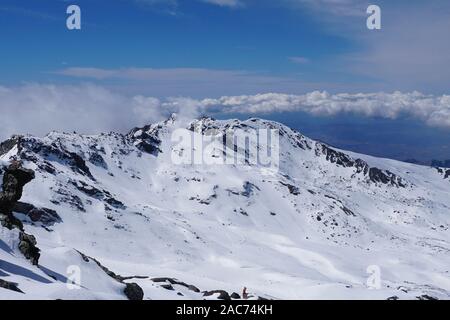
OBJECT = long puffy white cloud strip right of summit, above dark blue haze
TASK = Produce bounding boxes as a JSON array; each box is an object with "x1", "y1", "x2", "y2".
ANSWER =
[{"x1": 201, "y1": 91, "x2": 450, "y2": 127}]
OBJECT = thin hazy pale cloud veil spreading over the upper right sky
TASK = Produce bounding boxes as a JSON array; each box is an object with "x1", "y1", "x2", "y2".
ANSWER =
[{"x1": 281, "y1": 0, "x2": 450, "y2": 93}]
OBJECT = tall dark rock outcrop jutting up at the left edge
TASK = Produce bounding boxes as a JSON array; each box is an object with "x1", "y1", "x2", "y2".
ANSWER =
[{"x1": 0, "y1": 162, "x2": 34, "y2": 230}]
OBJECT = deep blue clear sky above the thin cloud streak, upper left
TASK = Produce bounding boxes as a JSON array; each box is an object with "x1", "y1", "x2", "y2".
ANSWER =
[{"x1": 0, "y1": 0, "x2": 356, "y2": 92}]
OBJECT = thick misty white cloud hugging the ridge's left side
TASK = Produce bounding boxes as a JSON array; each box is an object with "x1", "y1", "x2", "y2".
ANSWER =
[{"x1": 0, "y1": 84, "x2": 166, "y2": 139}]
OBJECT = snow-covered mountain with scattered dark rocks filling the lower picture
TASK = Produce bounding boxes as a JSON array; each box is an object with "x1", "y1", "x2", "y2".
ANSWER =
[{"x1": 0, "y1": 117, "x2": 450, "y2": 299}]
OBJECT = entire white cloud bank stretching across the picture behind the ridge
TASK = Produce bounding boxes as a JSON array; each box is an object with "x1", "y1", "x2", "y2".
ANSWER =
[{"x1": 0, "y1": 84, "x2": 450, "y2": 140}]
